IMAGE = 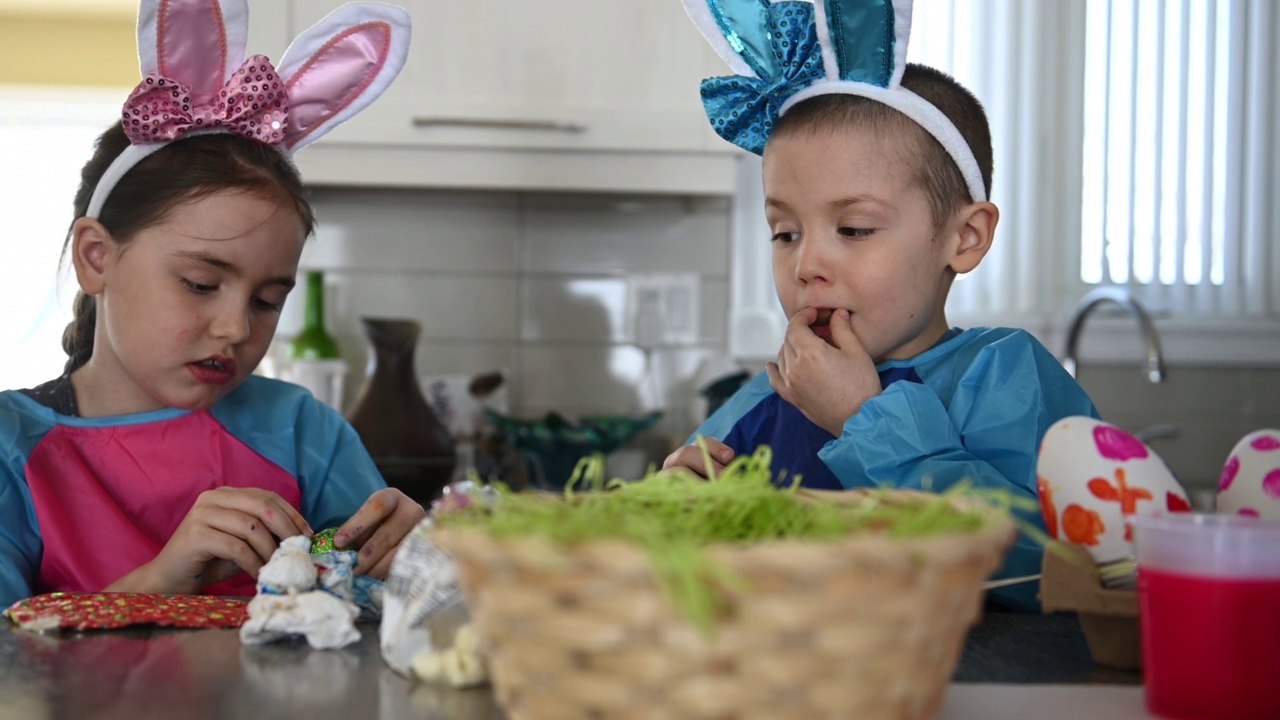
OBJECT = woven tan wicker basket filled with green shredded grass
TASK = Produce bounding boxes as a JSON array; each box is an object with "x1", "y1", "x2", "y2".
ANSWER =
[{"x1": 434, "y1": 491, "x2": 1015, "y2": 720}]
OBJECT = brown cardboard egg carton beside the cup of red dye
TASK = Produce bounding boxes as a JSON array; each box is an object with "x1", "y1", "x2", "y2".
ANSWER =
[{"x1": 1039, "y1": 542, "x2": 1142, "y2": 670}]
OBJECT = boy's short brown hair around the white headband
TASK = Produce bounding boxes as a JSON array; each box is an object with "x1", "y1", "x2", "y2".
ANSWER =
[{"x1": 771, "y1": 63, "x2": 992, "y2": 227}]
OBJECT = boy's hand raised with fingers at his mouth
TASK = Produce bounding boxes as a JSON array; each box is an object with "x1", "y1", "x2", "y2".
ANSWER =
[{"x1": 765, "y1": 307, "x2": 881, "y2": 437}]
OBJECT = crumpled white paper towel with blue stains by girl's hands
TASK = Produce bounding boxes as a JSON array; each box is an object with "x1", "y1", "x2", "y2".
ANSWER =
[{"x1": 241, "y1": 536, "x2": 368, "y2": 650}]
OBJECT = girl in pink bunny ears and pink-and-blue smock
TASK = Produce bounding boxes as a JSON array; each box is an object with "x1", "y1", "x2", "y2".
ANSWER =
[{"x1": 0, "y1": 0, "x2": 414, "y2": 606}]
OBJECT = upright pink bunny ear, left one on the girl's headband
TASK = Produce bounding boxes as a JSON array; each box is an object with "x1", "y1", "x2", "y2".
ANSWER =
[{"x1": 138, "y1": 0, "x2": 248, "y2": 105}]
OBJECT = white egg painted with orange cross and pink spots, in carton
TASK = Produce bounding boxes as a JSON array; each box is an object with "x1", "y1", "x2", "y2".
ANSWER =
[{"x1": 1036, "y1": 416, "x2": 1192, "y2": 562}]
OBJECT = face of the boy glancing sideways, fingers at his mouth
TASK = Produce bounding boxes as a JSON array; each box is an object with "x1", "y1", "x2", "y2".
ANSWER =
[{"x1": 764, "y1": 124, "x2": 954, "y2": 363}]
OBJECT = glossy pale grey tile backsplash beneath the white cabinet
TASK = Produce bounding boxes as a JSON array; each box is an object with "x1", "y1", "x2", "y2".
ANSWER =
[{"x1": 278, "y1": 188, "x2": 730, "y2": 439}]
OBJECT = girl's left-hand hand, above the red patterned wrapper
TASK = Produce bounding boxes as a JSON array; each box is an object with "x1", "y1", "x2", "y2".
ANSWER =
[{"x1": 106, "y1": 487, "x2": 314, "y2": 594}]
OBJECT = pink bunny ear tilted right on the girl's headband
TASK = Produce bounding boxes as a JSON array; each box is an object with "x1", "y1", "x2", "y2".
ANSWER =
[{"x1": 279, "y1": 3, "x2": 411, "y2": 152}]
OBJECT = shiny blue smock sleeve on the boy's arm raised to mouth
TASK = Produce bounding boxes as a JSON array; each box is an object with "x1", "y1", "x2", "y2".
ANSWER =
[{"x1": 819, "y1": 336, "x2": 1097, "y2": 610}]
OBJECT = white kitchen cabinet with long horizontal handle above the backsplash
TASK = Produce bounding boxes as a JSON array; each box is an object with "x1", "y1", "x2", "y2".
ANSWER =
[{"x1": 250, "y1": 0, "x2": 737, "y2": 195}]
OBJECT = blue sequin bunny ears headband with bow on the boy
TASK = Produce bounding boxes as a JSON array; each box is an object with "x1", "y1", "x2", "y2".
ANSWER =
[{"x1": 684, "y1": 0, "x2": 987, "y2": 202}]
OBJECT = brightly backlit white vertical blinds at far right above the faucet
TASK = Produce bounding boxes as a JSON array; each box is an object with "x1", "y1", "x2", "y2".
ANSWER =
[{"x1": 1079, "y1": 0, "x2": 1280, "y2": 319}]
